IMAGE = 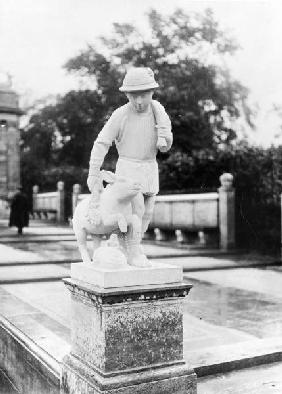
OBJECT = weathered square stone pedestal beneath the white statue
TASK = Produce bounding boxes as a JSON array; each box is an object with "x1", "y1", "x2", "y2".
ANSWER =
[{"x1": 61, "y1": 264, "x2": 196, "y2": 394}]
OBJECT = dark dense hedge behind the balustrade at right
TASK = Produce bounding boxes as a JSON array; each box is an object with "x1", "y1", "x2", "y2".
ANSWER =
[{"x1": 160, "y1": 142, "x2": 282, "y2": 252}]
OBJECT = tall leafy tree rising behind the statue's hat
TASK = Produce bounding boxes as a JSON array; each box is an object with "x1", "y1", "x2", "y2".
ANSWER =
[{"x1": 65, "y1": 9, "x2": 250, "y2": 152}]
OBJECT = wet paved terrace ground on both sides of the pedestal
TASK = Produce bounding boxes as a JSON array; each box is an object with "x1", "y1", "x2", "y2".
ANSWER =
[{"x1": 0, "y1": 219, "x2": 282, "y2": 394}]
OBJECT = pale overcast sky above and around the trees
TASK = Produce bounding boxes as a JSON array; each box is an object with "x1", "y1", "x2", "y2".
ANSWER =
[{"x1": 0, "y1": 0, "x2": 282, "y2": 143}]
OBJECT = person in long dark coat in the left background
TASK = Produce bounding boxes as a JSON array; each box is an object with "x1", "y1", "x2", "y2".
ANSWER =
[{"x1": 9, "y1": 187, "x2": 29, "y2": 234}]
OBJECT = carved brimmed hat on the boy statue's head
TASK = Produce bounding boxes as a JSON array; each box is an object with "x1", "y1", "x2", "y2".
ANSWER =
[{"x1": 119, "y1": 67, "x2": 159, "y2": 92}]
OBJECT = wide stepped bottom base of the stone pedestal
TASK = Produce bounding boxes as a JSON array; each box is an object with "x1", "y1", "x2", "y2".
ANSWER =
[{"x1": 61, "y1": 355, "x2": 197, "y2": 394}]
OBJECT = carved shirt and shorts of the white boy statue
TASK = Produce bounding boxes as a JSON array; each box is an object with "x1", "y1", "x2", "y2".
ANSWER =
[{"x1": 89, "y1": 100, "x2": 172, "y2": 188}]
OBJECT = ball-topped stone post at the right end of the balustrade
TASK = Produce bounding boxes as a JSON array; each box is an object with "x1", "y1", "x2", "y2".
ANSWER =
[{"x1": 218, "y1": 173, "x2": 235, "y2": 250}]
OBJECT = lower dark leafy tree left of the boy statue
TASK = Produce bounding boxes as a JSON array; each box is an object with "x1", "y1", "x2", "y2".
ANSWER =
[{"x1": 21, "y1": 90, "x2": 116, "y2": 190}]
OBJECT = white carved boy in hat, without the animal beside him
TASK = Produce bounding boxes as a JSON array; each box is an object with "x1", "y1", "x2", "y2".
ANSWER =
[{"x1": 87, "y1": 67, "x2": 172, "y2": 264}]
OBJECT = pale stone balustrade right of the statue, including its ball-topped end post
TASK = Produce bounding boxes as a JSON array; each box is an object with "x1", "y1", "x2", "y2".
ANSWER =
[{"x1": 72, "y1": 173, "x2": 235, "y2": 250}]
